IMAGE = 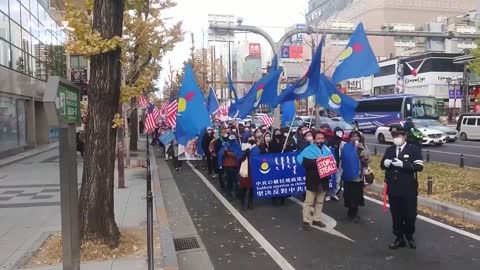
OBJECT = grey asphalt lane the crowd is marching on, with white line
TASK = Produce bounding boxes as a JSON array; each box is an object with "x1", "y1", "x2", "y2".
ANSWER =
[{"x1": 165, "y1": 156, "x2": 480, "y2": 270}]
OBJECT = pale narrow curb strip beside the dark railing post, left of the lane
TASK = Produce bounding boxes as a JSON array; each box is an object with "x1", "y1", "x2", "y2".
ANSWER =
[{"x1": 150, "y1": 149, "x2": 178, "y2": 270}]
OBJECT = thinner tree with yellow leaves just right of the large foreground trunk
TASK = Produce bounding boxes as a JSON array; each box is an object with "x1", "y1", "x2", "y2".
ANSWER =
[{"x1": 121, "y1": 0, "x2": 183, "y2": 150}]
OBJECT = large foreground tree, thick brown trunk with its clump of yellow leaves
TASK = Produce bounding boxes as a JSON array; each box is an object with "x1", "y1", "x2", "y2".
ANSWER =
[{"x1": 65, "y1": 0, "x2": 124, "y2": 247}]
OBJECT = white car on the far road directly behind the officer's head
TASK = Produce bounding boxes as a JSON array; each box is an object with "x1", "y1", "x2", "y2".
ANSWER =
[{"x1": 375, "y1": 122, "x2": 447, "y2": 145}]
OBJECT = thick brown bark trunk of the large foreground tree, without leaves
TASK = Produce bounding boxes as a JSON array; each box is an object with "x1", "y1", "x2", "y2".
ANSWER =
[{"x1": 79, "y1": 0, "x2": 124, "y2": 247}]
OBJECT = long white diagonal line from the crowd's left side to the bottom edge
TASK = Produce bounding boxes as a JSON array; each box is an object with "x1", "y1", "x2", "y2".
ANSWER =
[{"x1": 187, "y1": 161, "x2": 295, "y2": 270}]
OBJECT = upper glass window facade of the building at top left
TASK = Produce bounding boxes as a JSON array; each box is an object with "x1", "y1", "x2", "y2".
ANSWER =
[{"x1": 0, "y1": 0, "x2": 67, "y2": 80}]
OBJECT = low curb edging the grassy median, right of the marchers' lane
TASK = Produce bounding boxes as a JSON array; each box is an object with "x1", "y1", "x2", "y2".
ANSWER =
[{"x1": 369, "y1": 183, "x2": 480, "y2": 225}]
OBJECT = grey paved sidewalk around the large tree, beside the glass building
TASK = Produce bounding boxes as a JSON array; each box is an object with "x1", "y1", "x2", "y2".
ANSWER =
[{"x1": 0, "y1": 139, "x2": 163, "y2": 270}]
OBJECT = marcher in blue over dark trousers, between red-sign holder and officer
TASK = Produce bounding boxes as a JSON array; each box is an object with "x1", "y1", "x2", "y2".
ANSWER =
[{"x1": 340, "y1": 130, "x2": 368, "y2": 223}]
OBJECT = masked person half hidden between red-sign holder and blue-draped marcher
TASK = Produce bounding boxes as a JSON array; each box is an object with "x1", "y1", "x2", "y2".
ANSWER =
[{"x1": 325, "y1": 127, "x2": 345, "y2": 202}]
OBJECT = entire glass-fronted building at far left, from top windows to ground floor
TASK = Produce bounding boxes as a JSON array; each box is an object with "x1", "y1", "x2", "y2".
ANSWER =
[{"x1": 0, "y1": 0, "x2": 66, "y2": 156}]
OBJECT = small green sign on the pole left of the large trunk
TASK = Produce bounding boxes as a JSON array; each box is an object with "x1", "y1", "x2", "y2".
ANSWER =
[{"x1": 56, "y1": 82, "x2": 80, "y2": 124}]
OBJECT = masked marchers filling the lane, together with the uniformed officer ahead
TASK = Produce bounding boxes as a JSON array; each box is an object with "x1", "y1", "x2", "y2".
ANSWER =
[{"x1": 154, "y1": 119, "x2": 423, "y2": 249}]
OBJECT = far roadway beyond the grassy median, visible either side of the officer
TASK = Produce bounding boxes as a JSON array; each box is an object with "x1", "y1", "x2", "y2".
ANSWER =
[{"x1": 365, "y1": 134, "x2": 480, "y2": 168}]
